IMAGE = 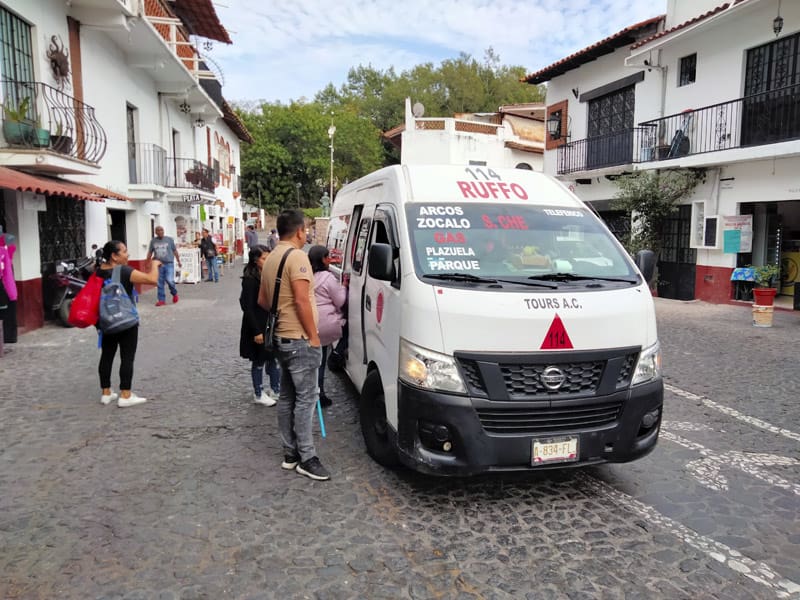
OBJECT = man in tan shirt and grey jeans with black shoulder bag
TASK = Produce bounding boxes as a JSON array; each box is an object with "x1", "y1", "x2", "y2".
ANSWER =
[{"x1": 258, "y1": 210, "x2": 331, "y2": 481}]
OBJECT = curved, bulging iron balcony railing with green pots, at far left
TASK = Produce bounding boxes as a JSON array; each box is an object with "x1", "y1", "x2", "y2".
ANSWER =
[{"x1": 2, "y1": 79, "x2": 108, "y2": 164}]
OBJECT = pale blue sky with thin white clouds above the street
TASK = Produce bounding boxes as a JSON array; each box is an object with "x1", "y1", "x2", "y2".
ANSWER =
[{"x1": 208, "y1": 0, "x2": 667, "y2": 104}]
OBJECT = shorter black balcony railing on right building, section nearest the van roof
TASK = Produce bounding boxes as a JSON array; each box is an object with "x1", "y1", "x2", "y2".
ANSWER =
[{"x1": 558, "y1": 127, "x2": 655, "y2": 175}]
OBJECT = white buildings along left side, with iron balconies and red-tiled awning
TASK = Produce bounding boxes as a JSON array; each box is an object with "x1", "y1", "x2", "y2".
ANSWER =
[{"x1": 0, "y1": 0, "x2": 251, "y2": 331}]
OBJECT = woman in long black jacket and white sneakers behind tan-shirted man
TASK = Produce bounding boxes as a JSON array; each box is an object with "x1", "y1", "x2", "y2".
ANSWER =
[{"x1": 239, "y1": 244, "x2": 281, "y2": 406}]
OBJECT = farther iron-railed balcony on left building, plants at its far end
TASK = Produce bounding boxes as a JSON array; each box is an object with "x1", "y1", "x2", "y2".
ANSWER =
[{"x1": 128, "y1": 143, "x2": 217, "y2": 193}]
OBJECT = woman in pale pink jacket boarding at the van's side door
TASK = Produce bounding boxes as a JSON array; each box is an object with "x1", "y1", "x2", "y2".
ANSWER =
[{"x1": 308, "y1": 246, "x2": 347, "y2": 406}]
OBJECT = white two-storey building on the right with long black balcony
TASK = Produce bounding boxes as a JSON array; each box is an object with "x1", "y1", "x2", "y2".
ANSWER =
[{"x1": 527, "y1": 0, "x2": 800, "y2": 306}]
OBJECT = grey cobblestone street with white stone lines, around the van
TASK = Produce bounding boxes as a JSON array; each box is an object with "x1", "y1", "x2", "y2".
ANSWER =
[{"x1": 0, "y1": 262, "x2": 800, "y2": 600}]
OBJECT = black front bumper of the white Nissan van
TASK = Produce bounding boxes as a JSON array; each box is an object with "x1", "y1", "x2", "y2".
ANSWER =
[{"x1": 397, "y1": 379, "x2": 664, "y2": 475}]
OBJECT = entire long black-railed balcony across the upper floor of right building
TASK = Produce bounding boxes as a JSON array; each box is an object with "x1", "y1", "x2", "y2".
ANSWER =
[{"x1": 557, "y1": 85, "x2": 800, "y2": 175}]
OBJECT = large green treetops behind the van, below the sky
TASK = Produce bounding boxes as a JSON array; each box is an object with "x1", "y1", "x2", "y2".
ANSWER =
[{"x1": 237, "y1": 48, "x2": 544, "y2": 212}]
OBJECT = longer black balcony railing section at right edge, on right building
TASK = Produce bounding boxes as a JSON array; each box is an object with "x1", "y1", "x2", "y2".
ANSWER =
[{"x1": 639, "y1": 85, "x2": 800, "y2": 158}]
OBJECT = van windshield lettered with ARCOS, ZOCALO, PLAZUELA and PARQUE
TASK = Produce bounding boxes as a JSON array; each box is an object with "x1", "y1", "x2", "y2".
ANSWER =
[{"x1": 406, "y1": 203, "x2": 639, "y2": 287}]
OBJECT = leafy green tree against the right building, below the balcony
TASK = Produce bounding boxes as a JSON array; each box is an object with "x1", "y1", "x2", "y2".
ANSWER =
[{"x1": 612, "y1": 169, "x2": 703, "y2": 256}]
